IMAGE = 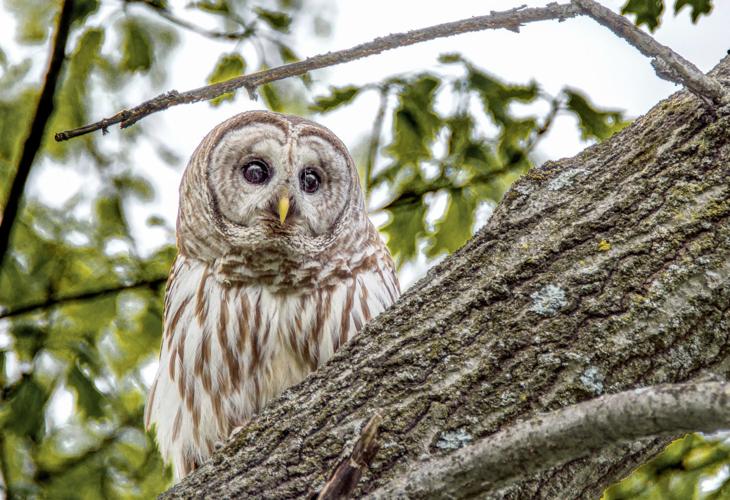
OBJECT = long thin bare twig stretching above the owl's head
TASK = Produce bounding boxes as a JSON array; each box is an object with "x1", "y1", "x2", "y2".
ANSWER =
[{"x1": 55, "y1": 3, "x2": 581, "y2": 141}]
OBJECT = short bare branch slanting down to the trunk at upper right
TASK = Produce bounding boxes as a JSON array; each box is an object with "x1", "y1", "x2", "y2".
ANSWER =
[{"x1": 573, "y1": 0, "x2": 730, "y2": 105}]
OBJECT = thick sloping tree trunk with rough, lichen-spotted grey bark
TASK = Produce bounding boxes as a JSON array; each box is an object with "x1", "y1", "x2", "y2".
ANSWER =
[{"x1": 164, "y1": 57, "x2": 730, "y2": 499}]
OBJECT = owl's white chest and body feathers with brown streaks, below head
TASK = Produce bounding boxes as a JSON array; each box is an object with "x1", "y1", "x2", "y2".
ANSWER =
[{"x1": 145, "y1": 249, "x2": 399, "y2": 478}]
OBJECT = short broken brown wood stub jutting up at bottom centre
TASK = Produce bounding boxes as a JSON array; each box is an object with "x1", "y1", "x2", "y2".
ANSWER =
[{"x1": 317, "y1": 413, "x2": 383, "y2": 500}]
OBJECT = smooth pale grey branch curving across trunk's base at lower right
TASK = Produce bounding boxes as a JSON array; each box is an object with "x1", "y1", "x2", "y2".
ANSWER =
[{"x1": 374, "y1": 382, "x2": 730, "y2": 498}]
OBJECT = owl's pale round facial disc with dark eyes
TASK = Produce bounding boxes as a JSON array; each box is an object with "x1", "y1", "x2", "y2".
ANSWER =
[{"x1": 208, "y1": 123, "x2": 352, "y2": 237}]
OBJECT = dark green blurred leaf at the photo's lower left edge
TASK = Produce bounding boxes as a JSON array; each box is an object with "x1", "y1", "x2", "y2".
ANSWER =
[{"x1": 0, "y1": 375, "x2": 50, "y2": 441}]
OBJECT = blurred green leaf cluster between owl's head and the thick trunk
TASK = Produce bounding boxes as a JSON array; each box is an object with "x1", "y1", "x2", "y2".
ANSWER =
[{"x1": 310, "y1": 54, "x2": 626, "y2": 265}]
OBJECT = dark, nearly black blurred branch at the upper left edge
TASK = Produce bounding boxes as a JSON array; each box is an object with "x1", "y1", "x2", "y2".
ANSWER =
[{"x1": 0, "y1": 0, "x2": 74, "y2": 266}]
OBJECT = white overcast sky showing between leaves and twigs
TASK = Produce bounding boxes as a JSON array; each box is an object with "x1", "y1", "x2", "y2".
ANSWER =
[{"x1": 0, "y1": 0, "x2": 730, "y2": 283}]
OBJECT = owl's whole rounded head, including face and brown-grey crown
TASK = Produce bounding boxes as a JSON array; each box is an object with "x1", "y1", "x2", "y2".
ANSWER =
[{"x1": 177, "y1": 111, "x2": 365, "y2": 260}]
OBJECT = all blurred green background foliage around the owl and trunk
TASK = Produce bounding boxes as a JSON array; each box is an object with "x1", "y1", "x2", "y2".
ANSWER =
[{"x1": 0, "y1": 0, "x2": 726, "y2": 498}]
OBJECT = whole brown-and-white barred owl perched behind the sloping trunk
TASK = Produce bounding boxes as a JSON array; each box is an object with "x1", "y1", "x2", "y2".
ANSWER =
[{"x1": 145, "y1": 111, "x2": 400, "y2": 479}]
